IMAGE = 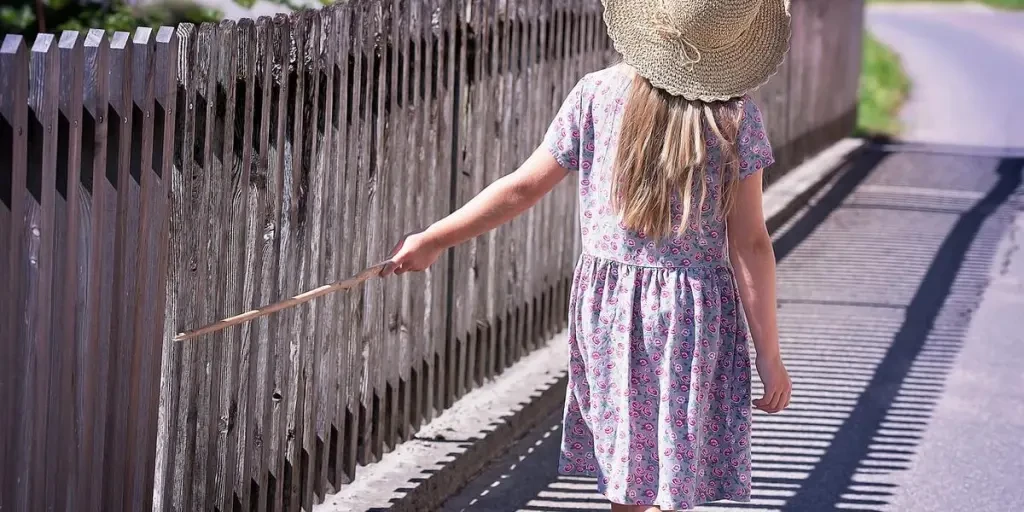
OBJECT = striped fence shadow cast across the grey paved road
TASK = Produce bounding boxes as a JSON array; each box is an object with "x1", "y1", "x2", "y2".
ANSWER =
[{"x1": 443, "y1": 143, "x2": 1024, "y2": 512}]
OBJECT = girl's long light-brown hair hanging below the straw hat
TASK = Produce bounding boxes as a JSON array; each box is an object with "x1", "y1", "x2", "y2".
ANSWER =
[{"x1": 611, "y1": 74, "x2": 742, "y2": 239}]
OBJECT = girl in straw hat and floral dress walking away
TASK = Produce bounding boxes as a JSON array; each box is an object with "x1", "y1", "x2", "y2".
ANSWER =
[{"x1": 385, "y1": 0, "x2": 791, "y2": 512}]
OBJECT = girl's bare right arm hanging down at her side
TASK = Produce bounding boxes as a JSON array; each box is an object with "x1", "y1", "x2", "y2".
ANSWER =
[{"x1": 727, "y1": 170, "x2": 792, "y2": 413}]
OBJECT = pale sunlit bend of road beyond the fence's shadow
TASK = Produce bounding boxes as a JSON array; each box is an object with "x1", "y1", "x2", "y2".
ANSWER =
[{"x1": 867, "y1": 4, "x2": 1024, "y2": 147}]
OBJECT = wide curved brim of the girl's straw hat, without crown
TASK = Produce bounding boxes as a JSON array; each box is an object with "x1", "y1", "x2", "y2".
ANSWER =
[{"x1": 602, "y1": 0, "x2": 792, "y2": 101}]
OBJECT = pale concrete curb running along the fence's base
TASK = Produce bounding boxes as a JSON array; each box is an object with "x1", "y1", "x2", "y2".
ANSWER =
[{"x1": 313, "y1": 138, "x2": 864, "y2": 512}]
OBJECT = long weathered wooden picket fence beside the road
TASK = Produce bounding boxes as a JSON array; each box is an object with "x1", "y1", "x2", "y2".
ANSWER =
[{"x1": 0, "y1": 0, "x2": 862, "y2": 511}]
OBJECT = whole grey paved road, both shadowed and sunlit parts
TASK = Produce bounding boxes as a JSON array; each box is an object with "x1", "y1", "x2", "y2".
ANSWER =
[{"x1": 443, "y1": 7, "x2": 1024, "y2": 512}]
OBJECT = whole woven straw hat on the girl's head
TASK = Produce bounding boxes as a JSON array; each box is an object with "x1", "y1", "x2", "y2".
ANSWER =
[{"x1": 602, "y1": 0, "x2": 791, "y2": 101}]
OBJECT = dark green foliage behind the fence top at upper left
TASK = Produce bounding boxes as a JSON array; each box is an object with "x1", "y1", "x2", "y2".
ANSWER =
[{"x1": 0, "y1": 0, "x2": 220, "y2": 40}]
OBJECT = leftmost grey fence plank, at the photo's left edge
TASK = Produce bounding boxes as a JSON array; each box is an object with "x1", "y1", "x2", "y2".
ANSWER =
[{"x1": 0, "y1": 35, "x2": 29, "y2": 510}]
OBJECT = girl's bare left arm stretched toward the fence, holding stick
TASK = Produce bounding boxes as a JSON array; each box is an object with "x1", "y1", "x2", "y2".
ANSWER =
[{"x1": 382, "y1": 146, "x2": 568, "y2": 274}]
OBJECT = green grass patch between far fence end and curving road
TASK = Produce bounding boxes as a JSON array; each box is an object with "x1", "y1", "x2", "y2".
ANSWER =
[{"x1": 856, "y1": 33, "x2": 910, "y2": 136}]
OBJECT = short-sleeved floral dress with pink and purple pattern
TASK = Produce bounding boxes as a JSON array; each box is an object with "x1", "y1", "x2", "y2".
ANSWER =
[{"x1": 545, "y1": 67, "x2": 774, "y2": 510}]
